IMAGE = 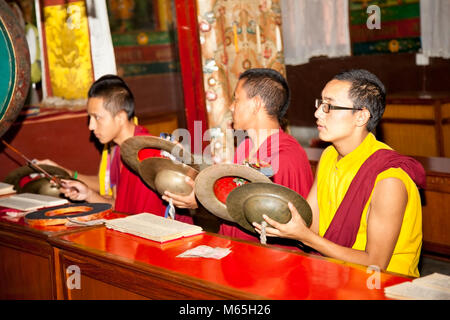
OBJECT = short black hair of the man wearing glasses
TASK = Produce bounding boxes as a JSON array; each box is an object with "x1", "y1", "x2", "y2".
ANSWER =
[{"x1": 333, "y1": 69, "x2": 386, "y2": 131}]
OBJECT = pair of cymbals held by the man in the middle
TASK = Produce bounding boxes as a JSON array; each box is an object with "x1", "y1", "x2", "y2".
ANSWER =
[{"x1": 120, "y1": 136, "x2": 198, "y2": 195}]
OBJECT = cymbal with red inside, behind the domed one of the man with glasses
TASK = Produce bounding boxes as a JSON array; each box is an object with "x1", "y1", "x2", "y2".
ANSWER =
[{"x1": 195, "y1": 163, "x2": 272, "y2": 221}]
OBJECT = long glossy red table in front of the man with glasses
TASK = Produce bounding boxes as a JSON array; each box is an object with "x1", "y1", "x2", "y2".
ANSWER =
[{"x1": 50, "y1": 227, "x2": 411, "y2": 300}]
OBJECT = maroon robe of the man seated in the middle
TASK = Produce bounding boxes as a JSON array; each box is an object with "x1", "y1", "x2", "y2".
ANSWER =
[{"x1": 219, "y1": 129, "x2": 313, "y2": 249}]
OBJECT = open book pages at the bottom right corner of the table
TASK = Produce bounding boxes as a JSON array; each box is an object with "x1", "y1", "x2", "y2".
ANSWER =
[{"x1": 384, "y1": 273, "x2": 450, "y2": 300}]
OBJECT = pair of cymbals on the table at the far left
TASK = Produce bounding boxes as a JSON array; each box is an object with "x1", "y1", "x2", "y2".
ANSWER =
[{"x1": 4, "y1": 164, "x2": 71, "y2": 197}]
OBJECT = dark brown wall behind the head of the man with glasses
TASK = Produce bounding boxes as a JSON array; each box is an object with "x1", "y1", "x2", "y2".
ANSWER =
[{"x1": 286, "y1": 53, "x2": 450, "y2": 127}]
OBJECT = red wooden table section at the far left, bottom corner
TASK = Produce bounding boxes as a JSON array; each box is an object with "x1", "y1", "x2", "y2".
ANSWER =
[{"x1": 0, "y1": 210, "x2": 124, "y2": 299}]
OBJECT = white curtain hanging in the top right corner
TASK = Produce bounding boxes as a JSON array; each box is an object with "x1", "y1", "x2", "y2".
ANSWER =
[{"x1": 420, "y1": 0, "x2": 450, "y2": 59}]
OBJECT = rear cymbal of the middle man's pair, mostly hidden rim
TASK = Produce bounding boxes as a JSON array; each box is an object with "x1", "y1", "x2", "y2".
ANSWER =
[{"x1": 120, "y1": 136, "x2": 198, "y2": 172}]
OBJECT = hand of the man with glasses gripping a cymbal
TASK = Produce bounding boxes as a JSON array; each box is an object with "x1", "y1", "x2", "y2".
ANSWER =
[{"x1": 253, "y1": 202, "x2": 312, "y2": 241}]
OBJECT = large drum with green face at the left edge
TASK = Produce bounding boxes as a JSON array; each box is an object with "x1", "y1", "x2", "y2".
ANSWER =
[{"x1": 0, "y1": 1, "x2": 30, "y2": 137}]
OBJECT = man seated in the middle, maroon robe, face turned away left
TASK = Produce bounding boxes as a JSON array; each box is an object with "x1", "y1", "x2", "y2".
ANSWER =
[{"x1": 163, "y1": 68, "x2": 313, "y2": 250}]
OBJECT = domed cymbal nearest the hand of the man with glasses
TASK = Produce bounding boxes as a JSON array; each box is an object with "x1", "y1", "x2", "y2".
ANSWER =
[{"x1": 227, "y1": 183, "x2": 312, "y2": 233}]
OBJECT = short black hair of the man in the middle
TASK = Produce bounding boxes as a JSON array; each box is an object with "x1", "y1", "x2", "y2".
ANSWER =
[{"x1": 239, "y1": 68, "x2": 290, "y2": 123}]
